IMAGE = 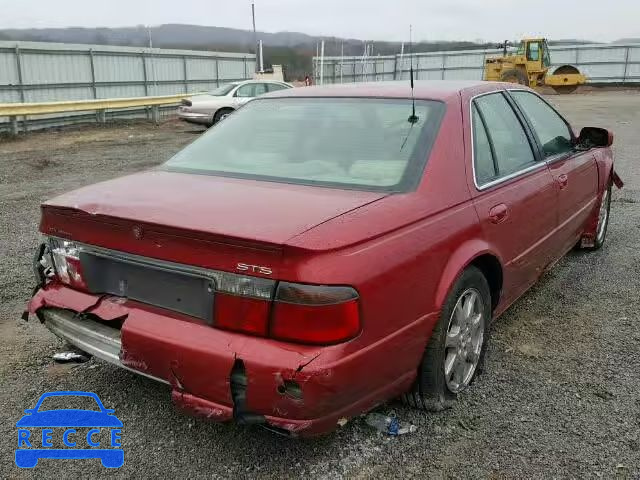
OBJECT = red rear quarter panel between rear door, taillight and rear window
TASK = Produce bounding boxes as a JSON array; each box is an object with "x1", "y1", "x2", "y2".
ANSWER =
[{"x1": 281, "y1": 93, "x2": 482, "y2": 378}]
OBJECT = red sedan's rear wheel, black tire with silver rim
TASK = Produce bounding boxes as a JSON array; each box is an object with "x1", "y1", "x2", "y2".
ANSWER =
[{"x1": 402, "y1": 267, "x2": 491, "y2": 411}]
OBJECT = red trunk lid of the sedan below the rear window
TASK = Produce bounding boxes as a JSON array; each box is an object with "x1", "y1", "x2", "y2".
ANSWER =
[{"x1": 41, "y1": 170, "x2": 385, "y2": 276}]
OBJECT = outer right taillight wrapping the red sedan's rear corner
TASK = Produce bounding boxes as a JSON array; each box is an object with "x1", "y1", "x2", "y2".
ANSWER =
[{"x1": 270, "y1": 282, "x2": 360, "y2": 345}]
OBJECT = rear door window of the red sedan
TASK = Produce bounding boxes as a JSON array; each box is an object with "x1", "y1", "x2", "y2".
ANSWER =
[{"x1": 474, "y1": 93, "x2": 536, "y2": 181}]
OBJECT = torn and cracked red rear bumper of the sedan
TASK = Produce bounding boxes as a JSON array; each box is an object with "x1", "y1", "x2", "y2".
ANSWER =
[{"x1": 29, "y1": 285, "x2": 424, "y2": 436}]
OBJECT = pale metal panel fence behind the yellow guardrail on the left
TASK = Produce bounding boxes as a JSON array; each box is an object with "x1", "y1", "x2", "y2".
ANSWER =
[{"x1": 0, "y1": 42, "x2": 255, "y2": 130}]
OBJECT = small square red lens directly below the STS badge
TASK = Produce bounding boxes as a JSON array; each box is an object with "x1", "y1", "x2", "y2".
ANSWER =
[{"x1": 213, "y1": 292, "x2": 271, "y2": 336}]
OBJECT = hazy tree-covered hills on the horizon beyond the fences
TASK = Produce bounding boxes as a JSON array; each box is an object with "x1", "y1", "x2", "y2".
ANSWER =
[{"x1": 0, "y1": 24, "x2": 608, "y2": 80}]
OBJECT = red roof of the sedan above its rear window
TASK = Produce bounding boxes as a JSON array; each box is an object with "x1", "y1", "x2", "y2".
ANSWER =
[{"x1": 268, "y1": 80, "x2": 503, "y2": 101}]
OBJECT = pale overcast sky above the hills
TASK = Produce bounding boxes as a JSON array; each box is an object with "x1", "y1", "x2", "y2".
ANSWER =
[{"x1": 0, "y1": 0, "x2": 640, "y2": 41}]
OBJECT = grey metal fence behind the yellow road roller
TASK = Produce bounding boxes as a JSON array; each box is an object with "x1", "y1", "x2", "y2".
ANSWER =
[{"x1": 313, "y1": 44, "x2": 640, "y2": 84}]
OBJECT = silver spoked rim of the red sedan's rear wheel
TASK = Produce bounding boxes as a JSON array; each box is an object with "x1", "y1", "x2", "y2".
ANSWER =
[{"x1": 444, "y1": 288, "x2": 485, "y2": 393}]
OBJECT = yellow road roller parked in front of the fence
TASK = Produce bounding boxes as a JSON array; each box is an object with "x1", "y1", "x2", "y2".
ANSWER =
[{"x1": 484, "y1": 38, "x2": 586, "y2": 93}]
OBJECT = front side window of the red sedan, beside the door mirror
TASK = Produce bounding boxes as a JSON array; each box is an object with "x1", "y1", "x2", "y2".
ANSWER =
[{"x1": 511, "y1": 91, "x2": 573, "y2": 157}]
